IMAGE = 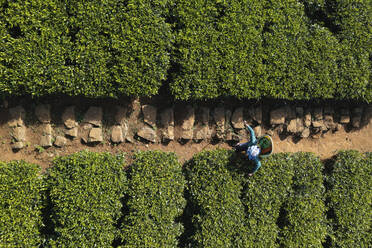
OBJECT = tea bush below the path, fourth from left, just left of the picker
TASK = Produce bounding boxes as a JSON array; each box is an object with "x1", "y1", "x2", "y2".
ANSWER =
[{"x1": 186, "y1": 150, "x2": 248, "y2": 248}]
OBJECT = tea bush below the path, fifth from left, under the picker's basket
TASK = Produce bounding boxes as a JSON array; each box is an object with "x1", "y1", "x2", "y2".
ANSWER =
[{"x1": 242, "y1": 153, "x2": 294, "y2": 248}]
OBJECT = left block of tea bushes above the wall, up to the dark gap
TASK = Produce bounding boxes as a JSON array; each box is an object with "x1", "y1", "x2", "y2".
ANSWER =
[{"x1": 0, "y1": 0, "x2": 172, "y2": 97}]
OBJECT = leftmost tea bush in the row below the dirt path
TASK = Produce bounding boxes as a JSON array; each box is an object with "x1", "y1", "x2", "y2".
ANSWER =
[{"x1": 0, "y1": 161, "x2": 43, "y2": 248}]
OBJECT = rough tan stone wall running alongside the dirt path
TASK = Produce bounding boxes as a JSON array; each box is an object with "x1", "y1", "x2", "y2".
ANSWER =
[{"x1": 6, "y1": 101, "x2": 372, "y2": 151}]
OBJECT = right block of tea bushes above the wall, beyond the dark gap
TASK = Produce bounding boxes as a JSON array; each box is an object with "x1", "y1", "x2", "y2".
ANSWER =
[{"x1": 170, "y1": 0, "x2": 372, "y2": 101}]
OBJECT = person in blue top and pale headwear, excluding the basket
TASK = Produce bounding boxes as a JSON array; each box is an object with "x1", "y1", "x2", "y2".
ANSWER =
[{"x1": 235, "y1": 121, "x2": 261, "y2": 176}]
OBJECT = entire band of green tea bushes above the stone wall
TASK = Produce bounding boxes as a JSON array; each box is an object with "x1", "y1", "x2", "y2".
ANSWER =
[{"x1": 0, "y1": 0, "x2": 372, "y2": 102}]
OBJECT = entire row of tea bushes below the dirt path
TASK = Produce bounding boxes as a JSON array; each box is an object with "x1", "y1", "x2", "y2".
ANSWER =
[{"x1": 0, "y1": 149, "x2": 372, "y2": 247}]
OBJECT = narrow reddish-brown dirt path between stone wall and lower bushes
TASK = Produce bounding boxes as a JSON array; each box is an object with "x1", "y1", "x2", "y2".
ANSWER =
[{"x1": 0, "y1": 123, "x2": 372, "y2": 168}]
